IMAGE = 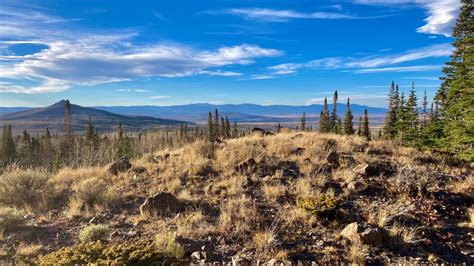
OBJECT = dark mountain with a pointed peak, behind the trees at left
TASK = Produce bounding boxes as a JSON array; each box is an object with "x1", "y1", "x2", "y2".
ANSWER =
[{"x1": 0, "y1": 100, "x2": 189, "y2": 132}]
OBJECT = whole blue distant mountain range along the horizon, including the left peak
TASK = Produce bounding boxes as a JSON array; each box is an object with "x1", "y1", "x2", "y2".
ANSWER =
[{"x1": 0, "y1": 101, "x2": 387, "y2": 131}]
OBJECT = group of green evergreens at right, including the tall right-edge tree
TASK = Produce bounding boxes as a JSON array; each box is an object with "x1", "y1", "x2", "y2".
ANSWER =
[{"x1": 383, "y1": 0, "x2": 474, "y2": 162}]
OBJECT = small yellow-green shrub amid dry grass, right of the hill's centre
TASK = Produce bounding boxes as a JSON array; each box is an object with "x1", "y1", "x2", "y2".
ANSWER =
[{"x1": 296, "y1": 194, "x2": 340, "y2": 216}]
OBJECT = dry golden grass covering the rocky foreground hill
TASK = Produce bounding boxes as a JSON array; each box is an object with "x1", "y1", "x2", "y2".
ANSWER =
[{"x1": 0, "y1": 131, "x2": 474, "y2": 264}]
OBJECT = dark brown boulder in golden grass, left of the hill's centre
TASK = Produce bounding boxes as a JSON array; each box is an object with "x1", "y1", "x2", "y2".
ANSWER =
[{"x1": 140, "y1": 192, "x2": 186, "y2": 216}]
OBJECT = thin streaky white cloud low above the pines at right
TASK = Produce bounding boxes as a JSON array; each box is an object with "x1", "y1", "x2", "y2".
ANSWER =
[{"x1": 268, "y1": 44, "x2": 452, "y2": 75}]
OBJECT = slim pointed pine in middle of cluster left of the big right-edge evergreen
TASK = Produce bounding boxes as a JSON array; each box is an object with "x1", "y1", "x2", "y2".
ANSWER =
[{"x1": 405, "y1": 83, "x2": 420, "y2": 145}]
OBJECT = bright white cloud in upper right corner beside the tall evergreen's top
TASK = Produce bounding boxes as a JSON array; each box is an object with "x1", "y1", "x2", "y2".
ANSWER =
[{"x1": 353, "y1": 0, "x2": 461, "y2": 37}]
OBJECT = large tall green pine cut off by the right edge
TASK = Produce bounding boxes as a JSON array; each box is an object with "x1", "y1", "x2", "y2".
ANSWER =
[{"x1": 435, "y1": 0, "x2": 474, "y2": 162}]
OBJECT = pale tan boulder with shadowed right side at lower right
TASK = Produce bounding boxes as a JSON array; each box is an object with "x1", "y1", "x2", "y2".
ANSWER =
[{"x1": 340, "y1": 222, "x2": 389, "y2": 246}]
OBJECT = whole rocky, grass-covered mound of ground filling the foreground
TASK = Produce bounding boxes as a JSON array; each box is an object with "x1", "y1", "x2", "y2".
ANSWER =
[{"x1": 0, "y1": 131, "x2": 474, "y2": 264}]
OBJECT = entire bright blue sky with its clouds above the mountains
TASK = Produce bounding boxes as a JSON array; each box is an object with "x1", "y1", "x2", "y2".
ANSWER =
[{"x1": 0, "y1": 0, "x2": 459, "y2": 106}]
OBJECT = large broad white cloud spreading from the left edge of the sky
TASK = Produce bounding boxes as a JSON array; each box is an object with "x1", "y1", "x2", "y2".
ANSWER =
[{"x1": 0, "y1": 4, "x2": 282, "y2": 93}]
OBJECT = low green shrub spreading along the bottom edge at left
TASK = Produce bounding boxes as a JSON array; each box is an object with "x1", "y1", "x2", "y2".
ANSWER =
[{"x1": 38, "y1": 241, "x2": 182, "y2": 265}]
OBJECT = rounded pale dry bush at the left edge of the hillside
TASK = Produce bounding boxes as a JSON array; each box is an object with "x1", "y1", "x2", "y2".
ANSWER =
[{"x1": 0, "y1": 170, "x2": 52, "y2": 211}]
